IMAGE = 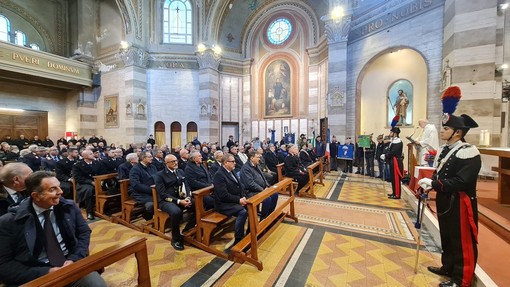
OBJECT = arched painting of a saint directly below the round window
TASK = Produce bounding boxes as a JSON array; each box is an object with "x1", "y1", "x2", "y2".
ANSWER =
[{"x1": 263, "y1": 60, "x2": 292, "y2": 117}]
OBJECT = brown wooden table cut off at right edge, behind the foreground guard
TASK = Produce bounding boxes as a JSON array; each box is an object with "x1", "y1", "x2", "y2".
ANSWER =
[{"x1": 478, "y1": 147, "x2": 510, "y2": 204}]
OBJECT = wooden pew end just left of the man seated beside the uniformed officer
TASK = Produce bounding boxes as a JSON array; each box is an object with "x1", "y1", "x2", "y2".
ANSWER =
[{"x1": 112, "y1": 179, "x2": 144, "y2": 231}]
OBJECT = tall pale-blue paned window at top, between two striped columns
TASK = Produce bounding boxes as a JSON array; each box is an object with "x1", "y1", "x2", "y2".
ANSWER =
[{"x1": 163, "y1": 0, "x2": 193, "y2": 44}]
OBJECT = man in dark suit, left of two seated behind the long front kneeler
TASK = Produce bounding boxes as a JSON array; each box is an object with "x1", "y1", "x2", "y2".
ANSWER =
[{"x1": 213, "y1": 153, "x2": 248, "y2": 245}]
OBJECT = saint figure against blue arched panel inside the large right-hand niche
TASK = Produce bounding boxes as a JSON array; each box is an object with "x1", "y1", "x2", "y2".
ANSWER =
[{"x1": 386, "y1": 79, "x2": 413, "y2": 126}]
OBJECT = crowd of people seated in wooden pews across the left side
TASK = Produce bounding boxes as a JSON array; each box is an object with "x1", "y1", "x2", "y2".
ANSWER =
[{"x1": 0, "y1": 134, "x2": 324, "y2": 286}]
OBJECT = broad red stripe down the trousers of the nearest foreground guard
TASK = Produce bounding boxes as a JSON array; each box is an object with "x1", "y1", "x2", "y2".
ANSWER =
[{"x1": 459, "y1": 192, "x2": 478, "y2": 286}]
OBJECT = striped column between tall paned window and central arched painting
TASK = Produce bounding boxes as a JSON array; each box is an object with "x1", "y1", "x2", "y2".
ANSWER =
[{"x1": 196, "y1": 48, "x2": 221, "y2": 145}]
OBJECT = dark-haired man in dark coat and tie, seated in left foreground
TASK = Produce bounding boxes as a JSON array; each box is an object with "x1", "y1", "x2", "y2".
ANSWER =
[{"x1": 0, "y1": 171, "x2": 106, "y2": 287}]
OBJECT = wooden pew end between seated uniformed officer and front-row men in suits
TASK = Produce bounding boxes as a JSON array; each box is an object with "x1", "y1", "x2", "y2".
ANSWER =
[{"x1": 184, "y1": 185, "x2": 229, "y2": 259}]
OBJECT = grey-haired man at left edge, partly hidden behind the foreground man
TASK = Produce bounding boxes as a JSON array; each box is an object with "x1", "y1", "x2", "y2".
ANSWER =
[{"x1": 0, "y1": 162, "x2": 32, "y2": 215}]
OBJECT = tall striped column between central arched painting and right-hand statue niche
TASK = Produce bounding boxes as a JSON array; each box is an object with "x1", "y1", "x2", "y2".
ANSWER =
[{"x1": 322, "y1": 7, "x2": 350, "y2": 139}]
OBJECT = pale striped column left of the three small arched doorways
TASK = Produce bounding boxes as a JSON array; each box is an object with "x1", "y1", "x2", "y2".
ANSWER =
[{"x1": 118, "y1": 46, "x2": 152, "y2": 144}]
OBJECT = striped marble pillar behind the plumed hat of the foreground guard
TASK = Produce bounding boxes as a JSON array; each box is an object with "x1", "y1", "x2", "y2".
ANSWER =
[{"x1": 443, "y1": 0, "x2": 503, "y2": 146}]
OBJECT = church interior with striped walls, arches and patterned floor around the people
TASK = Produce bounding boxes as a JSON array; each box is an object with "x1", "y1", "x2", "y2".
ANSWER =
[{"x1": 0, "y1": 0, "x2": 510, "y2": 287}]
